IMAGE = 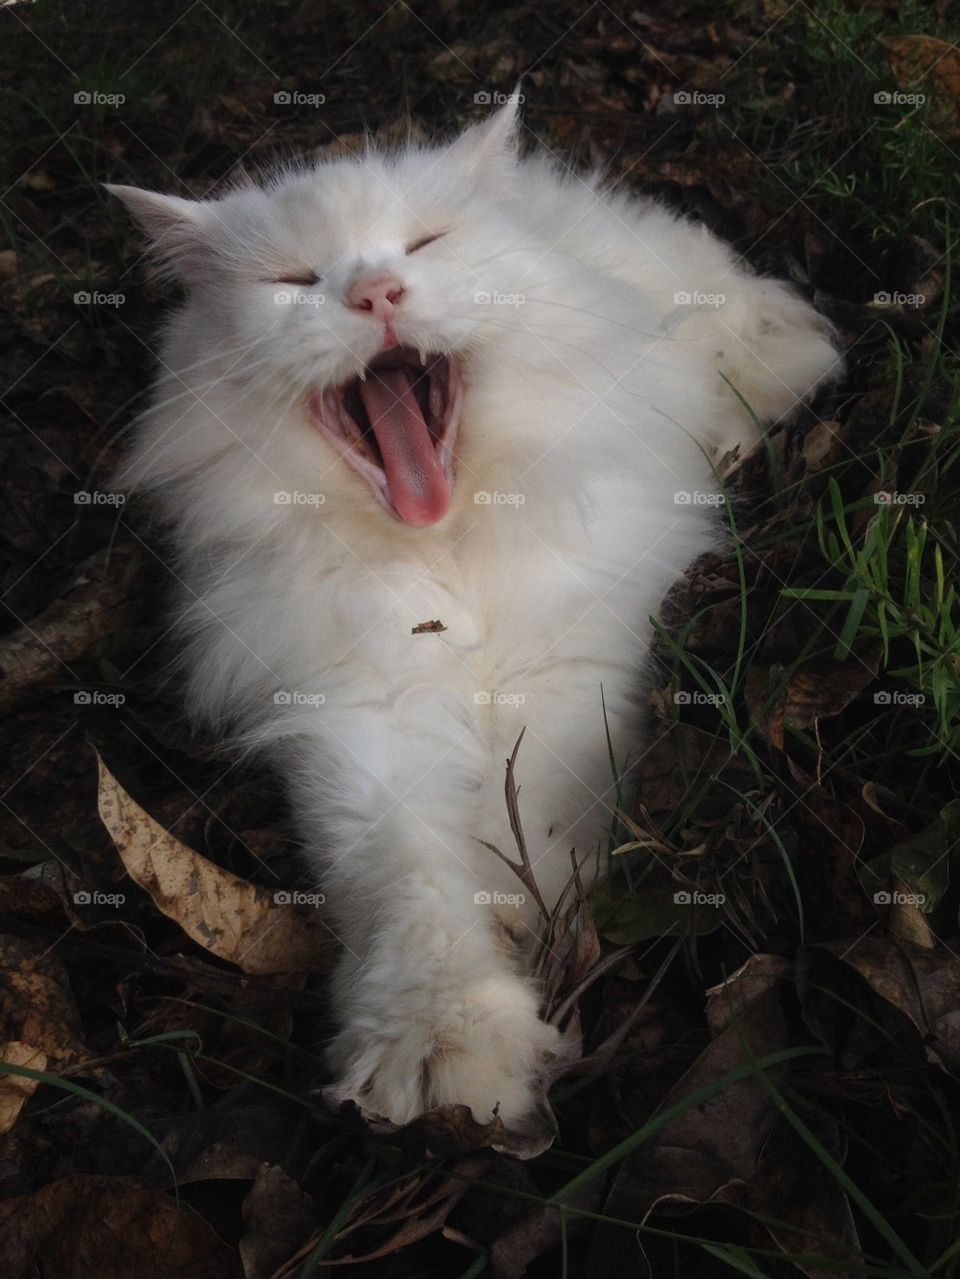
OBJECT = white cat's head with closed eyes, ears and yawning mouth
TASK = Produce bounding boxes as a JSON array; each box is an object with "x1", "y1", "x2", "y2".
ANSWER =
[{"x1": 109, "y1": 105, "x2": 534, "y2": 526}]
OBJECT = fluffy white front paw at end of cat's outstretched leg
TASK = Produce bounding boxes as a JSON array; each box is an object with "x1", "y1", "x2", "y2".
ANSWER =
[{"x1": 327, "y1": 975, "x2": 564, "y2": 1145}]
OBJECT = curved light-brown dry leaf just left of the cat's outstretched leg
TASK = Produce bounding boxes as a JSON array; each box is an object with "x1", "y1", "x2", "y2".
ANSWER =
[{"x1": 97, "y1": 756, "x2": 322, "y2": 975}]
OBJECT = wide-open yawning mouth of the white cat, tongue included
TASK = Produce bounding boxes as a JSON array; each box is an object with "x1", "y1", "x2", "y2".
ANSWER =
[{"x1": 309, "y1": 347, "x2": 463, "y2": 526}]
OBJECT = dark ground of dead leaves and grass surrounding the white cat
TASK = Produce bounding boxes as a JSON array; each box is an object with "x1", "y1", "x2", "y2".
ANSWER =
[{"x1": 0, "y1": 4, "x2": 960, "y2": 1279}]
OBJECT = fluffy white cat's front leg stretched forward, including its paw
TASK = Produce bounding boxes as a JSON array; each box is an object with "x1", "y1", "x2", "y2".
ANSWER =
[{"x1": 287, "y1": 688, "x2": 559, "y2": 1129}]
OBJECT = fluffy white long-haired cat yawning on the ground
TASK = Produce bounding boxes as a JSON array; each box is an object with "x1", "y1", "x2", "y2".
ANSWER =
[{"x1": 111, "y1": 97, "x2": 839, "y2": 1131}]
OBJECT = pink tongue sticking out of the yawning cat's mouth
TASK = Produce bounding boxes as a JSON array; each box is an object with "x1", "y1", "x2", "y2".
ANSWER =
[{"x1": 359, "y1": 368, "x2": 450, "y2": 524}]
